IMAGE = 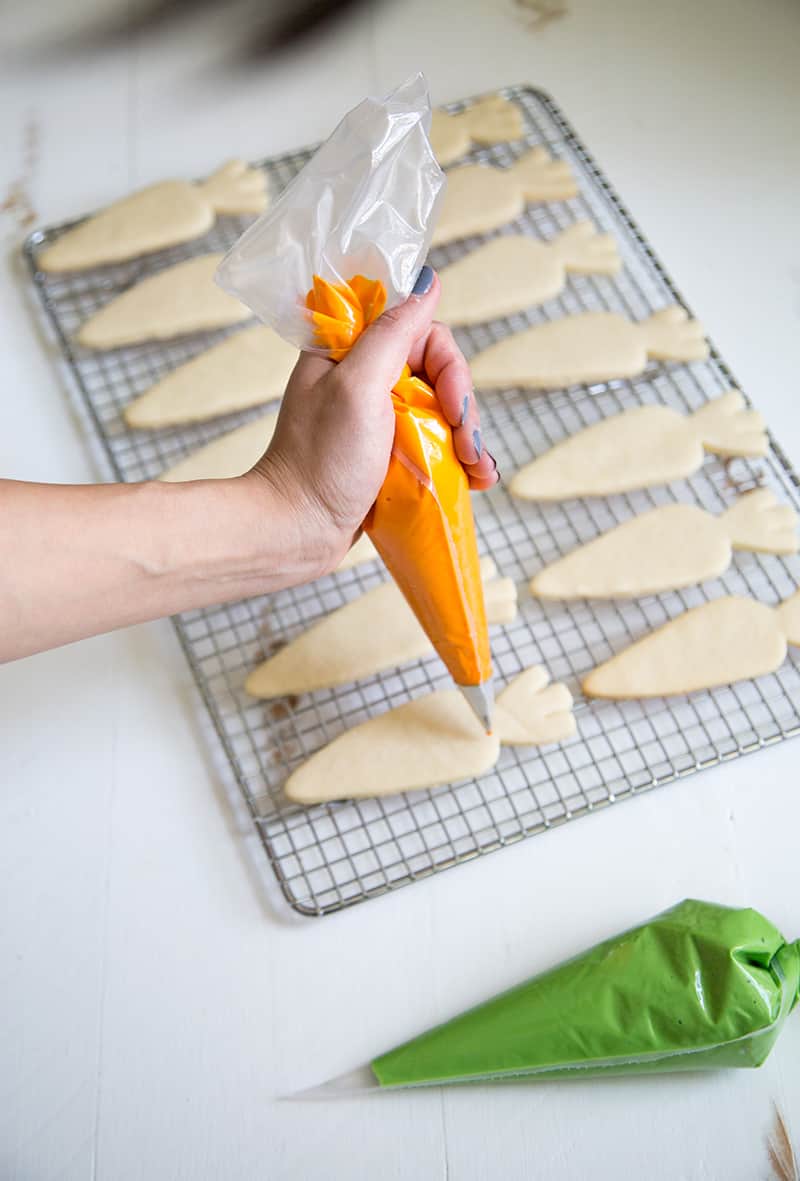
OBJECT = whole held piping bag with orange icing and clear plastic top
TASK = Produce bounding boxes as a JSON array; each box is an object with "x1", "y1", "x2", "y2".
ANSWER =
[{"x1": 216, "y1": 74, "x2": 493, "y2": 731}]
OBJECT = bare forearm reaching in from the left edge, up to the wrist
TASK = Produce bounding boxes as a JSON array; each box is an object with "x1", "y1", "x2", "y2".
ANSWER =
[{"x1": 0, "y1": 477, "x2": 318, "y2": 660}]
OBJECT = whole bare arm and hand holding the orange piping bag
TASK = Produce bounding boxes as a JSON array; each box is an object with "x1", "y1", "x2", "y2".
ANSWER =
[{"x1": 0, "y1": 277, "x2": 497, "y2": 660}]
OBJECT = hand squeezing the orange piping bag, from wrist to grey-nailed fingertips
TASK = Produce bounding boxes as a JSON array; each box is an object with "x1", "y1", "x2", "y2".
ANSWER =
[{"x1": 245, "y1": 268, "x2": 499, "y2": 578}]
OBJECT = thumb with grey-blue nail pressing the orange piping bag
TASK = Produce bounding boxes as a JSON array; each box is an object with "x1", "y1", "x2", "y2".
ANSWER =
[{"x1": 339, "y1": 266, "x2": 442, "y2": 394}]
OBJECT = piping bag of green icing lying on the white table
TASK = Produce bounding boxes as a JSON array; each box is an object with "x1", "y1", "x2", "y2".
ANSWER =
[{"x1": 293, "y1": 899, "x2": 800, "y2": 1098}]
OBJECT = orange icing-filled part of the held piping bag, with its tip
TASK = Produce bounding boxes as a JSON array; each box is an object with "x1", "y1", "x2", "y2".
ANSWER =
[{"x1": 306, "y1": 275, "x2": 493, "y2": 732}]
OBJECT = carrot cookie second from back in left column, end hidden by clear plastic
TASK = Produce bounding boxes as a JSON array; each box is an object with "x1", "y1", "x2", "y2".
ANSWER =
[{"x1": 76, "y1": 254, "x2": 252, "y2": 348}]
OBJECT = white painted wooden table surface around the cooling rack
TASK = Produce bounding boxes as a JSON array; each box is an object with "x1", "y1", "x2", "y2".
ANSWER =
[{"x1": 0, "y1": 0, "x2": 800, "y2": 1181}]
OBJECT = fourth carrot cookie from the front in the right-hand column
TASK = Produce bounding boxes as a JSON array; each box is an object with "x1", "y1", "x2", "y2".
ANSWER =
[{"x1": 469, "y1": 307, "x2": 708, "y2": 390}]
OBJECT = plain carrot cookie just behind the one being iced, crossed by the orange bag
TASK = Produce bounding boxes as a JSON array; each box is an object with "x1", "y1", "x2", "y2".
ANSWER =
[{"x1": 245, "y1": 557, "x2": 516, "y2": 698}]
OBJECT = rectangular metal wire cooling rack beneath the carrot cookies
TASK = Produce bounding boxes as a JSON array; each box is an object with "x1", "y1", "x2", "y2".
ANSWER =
[{"x1": 25, "y1": 87, "x2": 800, "y2": 914}]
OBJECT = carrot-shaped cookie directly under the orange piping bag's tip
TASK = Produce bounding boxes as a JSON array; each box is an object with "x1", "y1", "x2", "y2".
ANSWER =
[{"x1": 284, "y1": 665, "x2": 575, "y2": 804}]
